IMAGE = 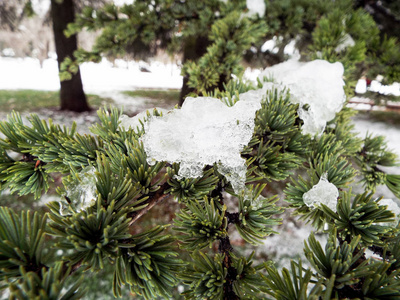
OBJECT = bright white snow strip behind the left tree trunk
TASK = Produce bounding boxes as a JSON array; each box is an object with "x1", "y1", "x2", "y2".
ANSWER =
[{"x1": 0, "y1": 57, "x2": 182, "y2": 94}]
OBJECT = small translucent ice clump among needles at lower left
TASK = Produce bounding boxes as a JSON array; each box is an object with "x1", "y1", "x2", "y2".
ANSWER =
[{"x1": 60, "y1": 166, "x2": 97, "y2": 214}]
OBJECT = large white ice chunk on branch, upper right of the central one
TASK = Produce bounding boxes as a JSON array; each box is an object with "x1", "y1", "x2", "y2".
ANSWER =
[{"x1": 259, "y1": 60, "x2": 346, "y2": 135}]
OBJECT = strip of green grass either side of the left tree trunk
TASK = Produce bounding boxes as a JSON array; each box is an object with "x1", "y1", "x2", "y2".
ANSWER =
[{"x1": 0, "y1": 90, "x2": 113, "y2": 112}]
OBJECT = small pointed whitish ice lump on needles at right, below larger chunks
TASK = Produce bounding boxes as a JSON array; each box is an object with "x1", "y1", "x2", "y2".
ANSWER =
[{"x1": 303, "y1": 173, "x2": 339, "y2": 212}]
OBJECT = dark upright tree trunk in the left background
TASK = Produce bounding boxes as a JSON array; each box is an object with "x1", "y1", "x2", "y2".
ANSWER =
[{"x1": 51, "y1": 0, "x2": 90, "y2": 112}]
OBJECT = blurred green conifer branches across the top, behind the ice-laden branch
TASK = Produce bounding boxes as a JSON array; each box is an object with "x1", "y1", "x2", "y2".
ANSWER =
[{"x1": 65, "y1": 0, "x2": 400, "y2": 106}]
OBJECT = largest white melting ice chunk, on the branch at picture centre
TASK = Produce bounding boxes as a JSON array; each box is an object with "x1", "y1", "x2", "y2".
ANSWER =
[{"x1": 142, "y1": 97, "x2": 261, "y2": 193}]
